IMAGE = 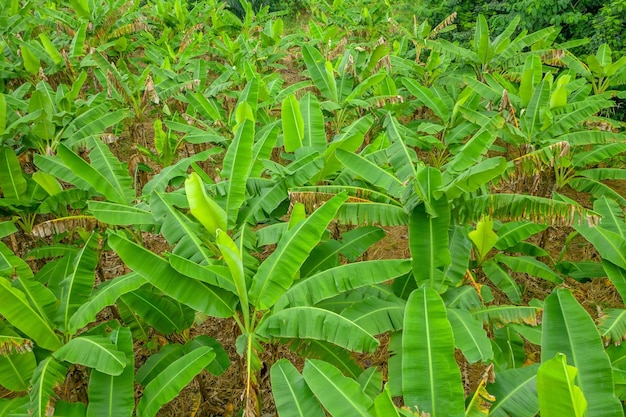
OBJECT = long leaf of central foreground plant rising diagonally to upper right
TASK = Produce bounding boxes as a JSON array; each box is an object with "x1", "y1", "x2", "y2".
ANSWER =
[{"x1": 249, "y1": 193, "x2": 348, "y2": 310}]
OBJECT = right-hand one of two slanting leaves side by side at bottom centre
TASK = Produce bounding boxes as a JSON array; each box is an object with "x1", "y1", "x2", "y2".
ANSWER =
[{"x1": 302, "y1": 359, "x2": 373, "y2": 417}]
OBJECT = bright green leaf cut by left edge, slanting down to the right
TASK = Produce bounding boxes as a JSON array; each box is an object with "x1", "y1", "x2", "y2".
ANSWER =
[{"x1": 0, "y1": 277, "x2": 61, "y2": 350}]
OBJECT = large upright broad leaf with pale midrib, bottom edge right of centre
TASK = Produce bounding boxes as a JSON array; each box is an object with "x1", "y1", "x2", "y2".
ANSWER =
[{"x1": 402, "y1": 287, "x2": 465, "y2": 417}]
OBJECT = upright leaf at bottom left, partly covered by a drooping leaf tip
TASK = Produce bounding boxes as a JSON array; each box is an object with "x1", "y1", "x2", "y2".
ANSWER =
[{"x1": 87, "y1": 327, "x2": 135, "y2": 417}]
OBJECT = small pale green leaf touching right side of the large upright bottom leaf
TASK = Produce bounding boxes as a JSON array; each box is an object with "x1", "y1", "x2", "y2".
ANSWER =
[{"x1": 447, "y1": 308, "x2": 493, "y2": 363}]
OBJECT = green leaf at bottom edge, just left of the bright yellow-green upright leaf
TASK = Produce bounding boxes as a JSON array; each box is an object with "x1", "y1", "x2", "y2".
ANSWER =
[{"x1": 487, "y1": 364, "x2": 539, "y2": 417}]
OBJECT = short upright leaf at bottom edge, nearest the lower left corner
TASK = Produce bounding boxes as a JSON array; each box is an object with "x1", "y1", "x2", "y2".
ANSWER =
[{"x1": 28, "y1": 356, "x2": 67, "y2": 417}]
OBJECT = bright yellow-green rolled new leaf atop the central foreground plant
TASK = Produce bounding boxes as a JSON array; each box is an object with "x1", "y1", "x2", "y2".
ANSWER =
[{"x1": 185, "y1": 172, "x2": 227, "y2": 235}]
